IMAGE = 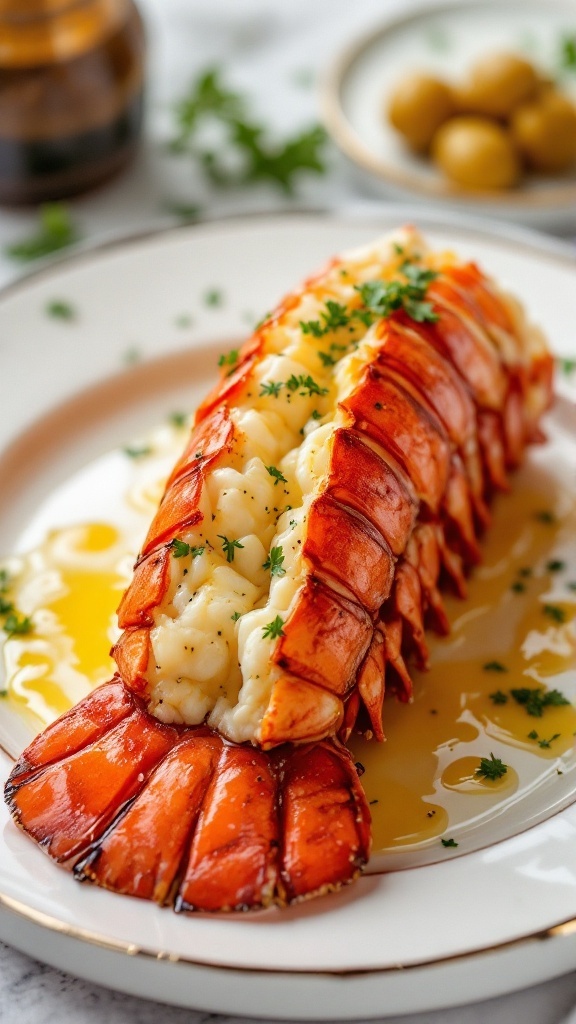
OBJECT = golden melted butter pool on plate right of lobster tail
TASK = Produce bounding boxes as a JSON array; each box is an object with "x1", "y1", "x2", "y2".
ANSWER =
[{"x1": 351, "y1": 480, "x2": 576, "y2": 852}]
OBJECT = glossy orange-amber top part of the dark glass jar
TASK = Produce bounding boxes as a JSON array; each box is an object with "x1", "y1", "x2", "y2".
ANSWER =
[{"x1": 0, "y1": 0, "x2": 132, "y2": 69}]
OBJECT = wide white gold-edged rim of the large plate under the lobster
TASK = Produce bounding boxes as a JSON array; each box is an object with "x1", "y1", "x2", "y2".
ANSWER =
[{"x1": 0, "y1": 209, "x2": 576, "y2": 1020}]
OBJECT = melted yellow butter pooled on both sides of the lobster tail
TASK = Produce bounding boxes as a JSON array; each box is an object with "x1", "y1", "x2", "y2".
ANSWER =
[{"x1": 4, "y1": 428, "x2": 576, "y2": 852}]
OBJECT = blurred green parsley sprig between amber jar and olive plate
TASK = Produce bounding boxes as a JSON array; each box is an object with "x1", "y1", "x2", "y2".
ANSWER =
[{"x1": 170, "y1": 68, "x2": 326, "y2": 195}]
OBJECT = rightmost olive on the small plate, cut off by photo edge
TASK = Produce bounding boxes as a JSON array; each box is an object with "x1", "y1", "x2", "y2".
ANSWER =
[{"x1": 510, "y1": 89, "x2": 576, "y2": 174}]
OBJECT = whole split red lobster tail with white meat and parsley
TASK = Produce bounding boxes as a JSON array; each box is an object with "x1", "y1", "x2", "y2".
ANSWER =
[{"x1": 6, "y1": 228, "x2": 552, "y2": 910}]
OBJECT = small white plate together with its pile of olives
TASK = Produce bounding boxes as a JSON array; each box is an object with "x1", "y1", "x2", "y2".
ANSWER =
[{"x1": 322, "y1": 0, "x2": 576, "y2": 229}]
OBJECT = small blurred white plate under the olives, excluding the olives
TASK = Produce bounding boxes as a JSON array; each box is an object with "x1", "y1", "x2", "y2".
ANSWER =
[{"x1": 322, "y1": 0, "x2": 576, "y2": 229}]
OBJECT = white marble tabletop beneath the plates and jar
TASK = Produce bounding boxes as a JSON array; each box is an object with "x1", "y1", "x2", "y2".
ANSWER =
[{"x1": 0, "y1": 0, "x2": 576, "y2": 1024}]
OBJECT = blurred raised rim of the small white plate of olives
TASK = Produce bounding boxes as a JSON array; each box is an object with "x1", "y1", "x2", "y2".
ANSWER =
[{"x1": 319, "y1": 0, "x2": 576, "y2": 208}]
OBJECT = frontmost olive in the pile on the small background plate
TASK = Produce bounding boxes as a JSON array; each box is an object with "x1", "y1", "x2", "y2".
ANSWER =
[{"x1": 433, "y1": 117, "x2": 521, "y2": 188}]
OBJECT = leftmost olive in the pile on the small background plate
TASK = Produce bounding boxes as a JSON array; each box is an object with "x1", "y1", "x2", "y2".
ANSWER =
[{"x1": 387, "y1": 74, "x2": 455, "y2": 153}]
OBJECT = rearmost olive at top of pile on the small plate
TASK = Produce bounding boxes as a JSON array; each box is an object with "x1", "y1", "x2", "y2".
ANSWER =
[{"x1": 456, "y1": 53, "x2": 540, "y2": 118}]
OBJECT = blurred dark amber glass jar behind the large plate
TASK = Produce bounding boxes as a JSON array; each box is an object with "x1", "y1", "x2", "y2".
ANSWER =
[{"x1": 0, "y1": 0, "x2": 145, "y2": 205}]
